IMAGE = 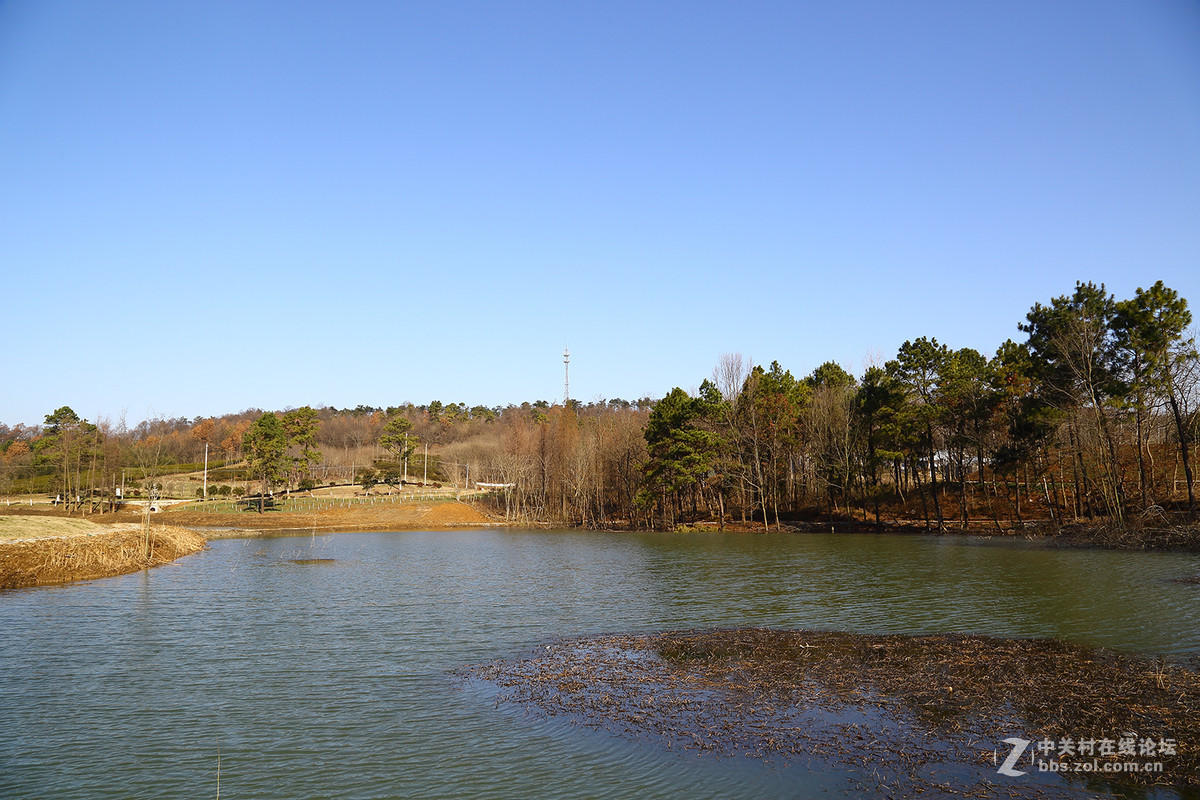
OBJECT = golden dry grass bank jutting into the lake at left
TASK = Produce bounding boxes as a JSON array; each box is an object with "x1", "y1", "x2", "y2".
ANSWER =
[{"x1": 0, "y1": 524, "x2": 205, "y2": 590}]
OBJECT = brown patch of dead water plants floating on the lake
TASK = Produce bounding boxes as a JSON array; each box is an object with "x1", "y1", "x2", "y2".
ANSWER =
[{"x1": 463, "y1": 628, "x2": 1200, "y2": 796}]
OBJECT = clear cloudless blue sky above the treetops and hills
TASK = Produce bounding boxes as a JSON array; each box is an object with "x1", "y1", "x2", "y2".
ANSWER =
[{"x1": 0, "y1": 0, "x2": 1200, "y2": 425}]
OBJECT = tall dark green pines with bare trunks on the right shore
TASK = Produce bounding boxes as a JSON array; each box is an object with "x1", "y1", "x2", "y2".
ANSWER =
[{"x1": 638, "y1": 282, "x2": 1198, "y2": 530}]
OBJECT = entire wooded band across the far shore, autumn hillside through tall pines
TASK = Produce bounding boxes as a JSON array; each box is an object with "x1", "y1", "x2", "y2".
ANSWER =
[{"x1": 0, "y1": 282, "x2": 1200, "y2": 530}]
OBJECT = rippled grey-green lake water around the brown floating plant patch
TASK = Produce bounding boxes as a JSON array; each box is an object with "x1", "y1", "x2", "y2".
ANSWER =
[{"x1": 0, "y1": 529, "x2": 1200, "y2": 800}]
